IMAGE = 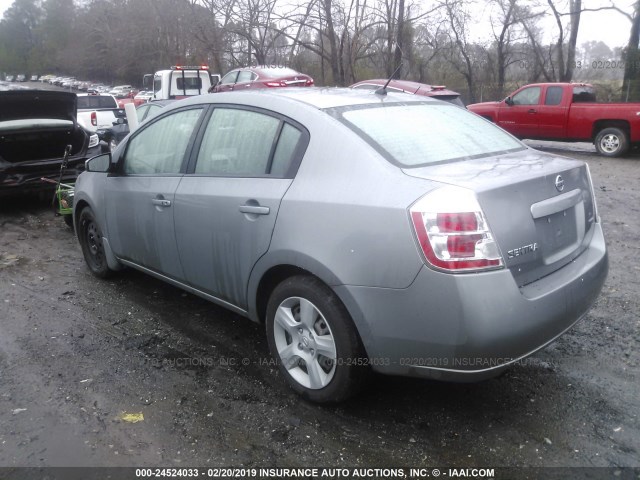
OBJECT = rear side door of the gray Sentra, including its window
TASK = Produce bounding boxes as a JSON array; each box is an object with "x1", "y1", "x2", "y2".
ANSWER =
[{"x1": 175, "y1": 106, "x2": 308, "y2": 309}]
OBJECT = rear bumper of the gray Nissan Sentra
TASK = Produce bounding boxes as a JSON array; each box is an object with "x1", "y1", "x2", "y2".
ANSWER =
[{"x1": 335, "y1": 224, "x2": 608, "y2": 381}]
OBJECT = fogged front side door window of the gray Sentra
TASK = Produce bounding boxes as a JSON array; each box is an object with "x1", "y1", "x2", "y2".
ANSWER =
[{"x1": 124, "y1": 108, "x2": 202, "y2": 175}]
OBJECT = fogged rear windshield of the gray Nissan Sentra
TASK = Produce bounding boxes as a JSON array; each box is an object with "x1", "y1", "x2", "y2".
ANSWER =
[{"x1": 340, "y1": 102, "x2": 526, "y2": 167}]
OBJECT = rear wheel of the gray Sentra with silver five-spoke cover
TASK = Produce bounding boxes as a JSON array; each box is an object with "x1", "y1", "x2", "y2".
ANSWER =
[{"x1": 266, "y1": 275, "x2": 369, "y2": 403}]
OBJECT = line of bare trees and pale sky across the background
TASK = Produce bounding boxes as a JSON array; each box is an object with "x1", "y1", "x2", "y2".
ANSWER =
[{"x1": 0, "y1": 0, "x2": 640, "y2": 102}]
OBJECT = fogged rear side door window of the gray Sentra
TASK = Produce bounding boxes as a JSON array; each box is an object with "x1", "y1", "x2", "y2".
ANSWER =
[{"x1": 195, "y1": 108, "x2": 302, "y2": 177}]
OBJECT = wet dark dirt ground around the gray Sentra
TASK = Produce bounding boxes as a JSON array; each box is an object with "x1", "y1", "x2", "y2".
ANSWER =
[{"x1": 0, "y1": 140, "x2": 640, "y2": 478}]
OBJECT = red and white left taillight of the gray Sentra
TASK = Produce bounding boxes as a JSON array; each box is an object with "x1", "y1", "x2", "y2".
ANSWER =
[{"x1": 409, "y1": 187, "x2": 503, "y2": 272}]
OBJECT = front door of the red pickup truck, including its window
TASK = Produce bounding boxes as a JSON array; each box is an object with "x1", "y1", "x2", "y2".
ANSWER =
[{"x1": 497, "y1": 85, "x2": 541, "y2": 138}]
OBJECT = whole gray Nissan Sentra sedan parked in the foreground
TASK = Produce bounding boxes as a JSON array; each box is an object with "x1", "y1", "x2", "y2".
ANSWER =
[{"x1": 74, "y1": 88, "x2": 608, "y2": 402}]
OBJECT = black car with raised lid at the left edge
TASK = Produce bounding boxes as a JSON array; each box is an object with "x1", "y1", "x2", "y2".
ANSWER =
[{"x1": 0, "y1": 90, "x2": 102, "y2": 195}]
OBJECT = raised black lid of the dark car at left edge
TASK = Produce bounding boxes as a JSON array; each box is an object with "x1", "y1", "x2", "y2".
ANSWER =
[{"x1": 0, "y1": 90, "x2": 77, "y2": 123}]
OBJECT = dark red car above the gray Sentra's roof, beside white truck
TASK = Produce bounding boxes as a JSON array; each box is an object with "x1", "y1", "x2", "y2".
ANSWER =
[{"x1": 209, "y1": 66, "x2": 313, "y2": 93}]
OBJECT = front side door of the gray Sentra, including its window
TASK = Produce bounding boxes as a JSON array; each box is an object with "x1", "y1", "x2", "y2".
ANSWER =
[{"x1": 105, "y1": 107, "x2": 203, "y2": 279}]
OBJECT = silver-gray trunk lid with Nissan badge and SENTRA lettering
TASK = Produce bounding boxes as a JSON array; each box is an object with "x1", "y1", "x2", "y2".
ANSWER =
[{"x1": 403, "y1": 149, "x2": 596, "y2": 286}]
